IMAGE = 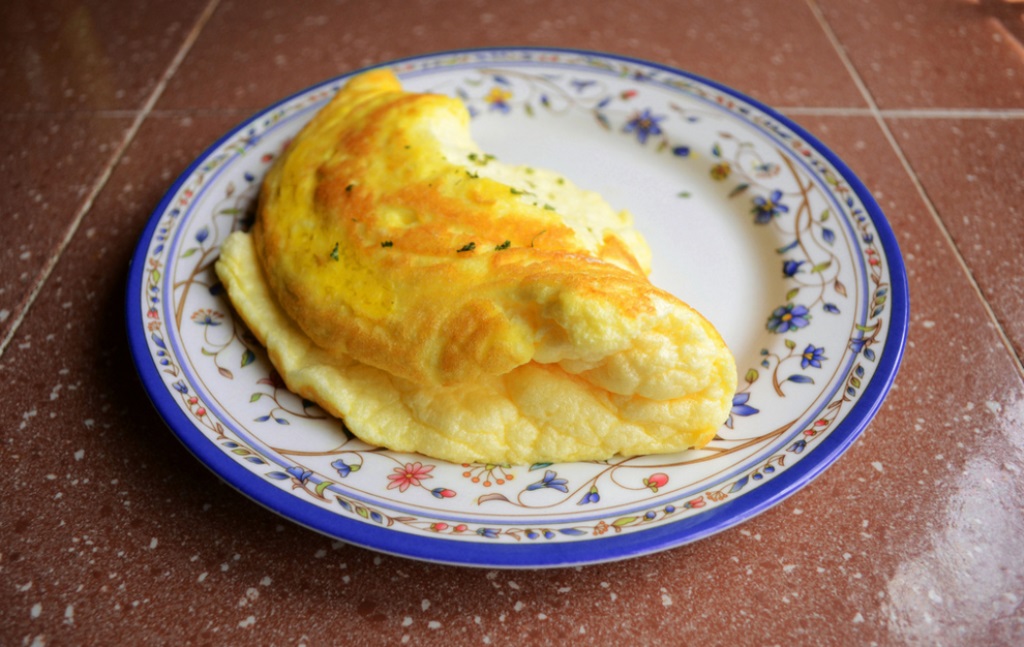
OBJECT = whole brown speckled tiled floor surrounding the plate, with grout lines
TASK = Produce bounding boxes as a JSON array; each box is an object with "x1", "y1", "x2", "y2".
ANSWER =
[{"x1": 0, "y1": 0, "x2": 1024, "y2": 645}]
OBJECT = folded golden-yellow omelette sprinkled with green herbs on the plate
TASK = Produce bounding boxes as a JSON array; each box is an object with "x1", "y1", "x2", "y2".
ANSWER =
[{"x1": 216, "y1": 70, "x2": 736, "y2": 464}]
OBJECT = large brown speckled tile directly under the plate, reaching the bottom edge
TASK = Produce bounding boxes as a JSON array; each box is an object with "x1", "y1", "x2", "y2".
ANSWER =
[{"x1": 0, "y1": 108, "x2": 1024, "y2": 645}]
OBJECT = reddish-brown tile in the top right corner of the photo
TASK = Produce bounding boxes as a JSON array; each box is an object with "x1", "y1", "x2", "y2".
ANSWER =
[{"x1": 818, "y1": 0, "x2": 1024, "y2": 109}]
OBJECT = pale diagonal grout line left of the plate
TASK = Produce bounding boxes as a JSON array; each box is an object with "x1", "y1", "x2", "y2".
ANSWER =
[{"x1": 0, "y1": 0, "x2": 220, "y2": 358}]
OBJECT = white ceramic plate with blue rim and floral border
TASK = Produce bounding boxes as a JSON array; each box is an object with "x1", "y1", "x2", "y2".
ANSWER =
[{"x1": 127, "y1": 49, "x2": 907, "y2": 567}]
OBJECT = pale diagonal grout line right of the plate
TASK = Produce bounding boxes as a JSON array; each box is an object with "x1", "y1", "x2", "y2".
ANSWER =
[{"x1": 806, "y1": 0, "x2": 1024, "y2": 379}]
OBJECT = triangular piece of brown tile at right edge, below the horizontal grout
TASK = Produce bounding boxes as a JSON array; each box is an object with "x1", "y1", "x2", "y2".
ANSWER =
[{"x1": 892, "y1": 119, "x2": 1024, "y2": 357}]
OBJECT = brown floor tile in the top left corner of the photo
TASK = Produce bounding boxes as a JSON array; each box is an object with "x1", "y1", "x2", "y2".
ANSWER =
[{"x1": 0, "y1": 0, "x2": 207, "y2": 112}]
